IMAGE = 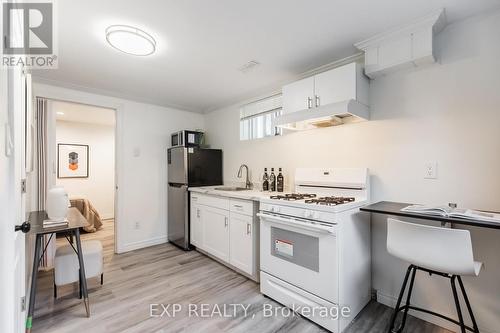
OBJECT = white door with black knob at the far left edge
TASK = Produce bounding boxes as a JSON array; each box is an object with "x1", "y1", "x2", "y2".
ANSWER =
[{"x1": 0, "y1": 68, "x2": 28, "y2": 333}]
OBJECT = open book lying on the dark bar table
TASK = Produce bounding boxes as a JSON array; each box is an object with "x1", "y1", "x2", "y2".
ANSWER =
[{"x1": 401, "y1": 205, "x2": 500, "y2": 223}]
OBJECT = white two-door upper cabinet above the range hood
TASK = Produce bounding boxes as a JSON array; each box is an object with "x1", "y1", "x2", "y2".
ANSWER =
[{"x1": 283, "y1": 62, "x2": 369, "y2": 113}]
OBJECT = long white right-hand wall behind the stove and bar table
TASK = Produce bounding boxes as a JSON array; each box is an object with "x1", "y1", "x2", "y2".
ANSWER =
[{"x1": 206, "y1": 12, "x2": 500, "y2": 333}]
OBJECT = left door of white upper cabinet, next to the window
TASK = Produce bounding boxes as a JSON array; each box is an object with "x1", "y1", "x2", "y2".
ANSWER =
[{"x1": 282, "y1": 77, "x2": 314, "y2": 113}]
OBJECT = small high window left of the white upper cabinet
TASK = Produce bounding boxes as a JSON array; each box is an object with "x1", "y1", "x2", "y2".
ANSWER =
[{"x1": 240, "y1": 94, "x2": 282, "y2": 140}]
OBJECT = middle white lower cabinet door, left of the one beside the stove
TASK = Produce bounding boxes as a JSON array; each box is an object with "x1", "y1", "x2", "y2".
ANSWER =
[{"x1": 201, "y1": 206, "x2": 229, "y2": 261}]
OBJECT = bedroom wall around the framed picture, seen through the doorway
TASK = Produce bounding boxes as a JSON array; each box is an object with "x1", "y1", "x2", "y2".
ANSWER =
[{"x1": 56, "y1": 120, "x2": 115, "y2": 219}]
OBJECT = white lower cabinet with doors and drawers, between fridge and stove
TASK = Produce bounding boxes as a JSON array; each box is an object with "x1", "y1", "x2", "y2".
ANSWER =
[{"x1": 190, "y1": 193, "x2": 259, "y2": 280}]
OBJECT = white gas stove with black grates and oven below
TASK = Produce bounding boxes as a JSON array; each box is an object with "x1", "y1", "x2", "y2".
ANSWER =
[{"x1": 257, "y1": 168, "x2": 371, "y2": 333}]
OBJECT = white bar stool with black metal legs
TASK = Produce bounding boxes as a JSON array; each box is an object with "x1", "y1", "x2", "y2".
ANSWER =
[{"x1": 387, "y1": 218, "x2": 483, "y2": 333}]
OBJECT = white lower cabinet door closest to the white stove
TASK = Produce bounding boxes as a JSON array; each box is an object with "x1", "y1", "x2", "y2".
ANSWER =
[{"x1": 229, "y1": 213, "x2": 254, "y2": 274}]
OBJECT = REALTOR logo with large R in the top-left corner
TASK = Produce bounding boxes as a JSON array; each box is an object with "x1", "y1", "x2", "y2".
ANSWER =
[{"x1": 2, "y1": 0, "x2": 57, "y2": 68}]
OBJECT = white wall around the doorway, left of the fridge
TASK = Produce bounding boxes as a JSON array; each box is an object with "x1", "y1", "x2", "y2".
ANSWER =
[{"x1": 34, "y1": 82, "x2": 204, "y2": 252}]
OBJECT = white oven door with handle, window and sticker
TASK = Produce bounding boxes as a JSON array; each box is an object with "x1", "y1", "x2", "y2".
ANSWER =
[{"x1": 258, "y1": 212, "x2": 339, "y2": 304}]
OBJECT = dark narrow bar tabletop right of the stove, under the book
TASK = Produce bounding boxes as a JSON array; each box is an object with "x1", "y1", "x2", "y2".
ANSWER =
[{"x1": 360, "y1": 201, "x2": 500, "y2": 229}]
